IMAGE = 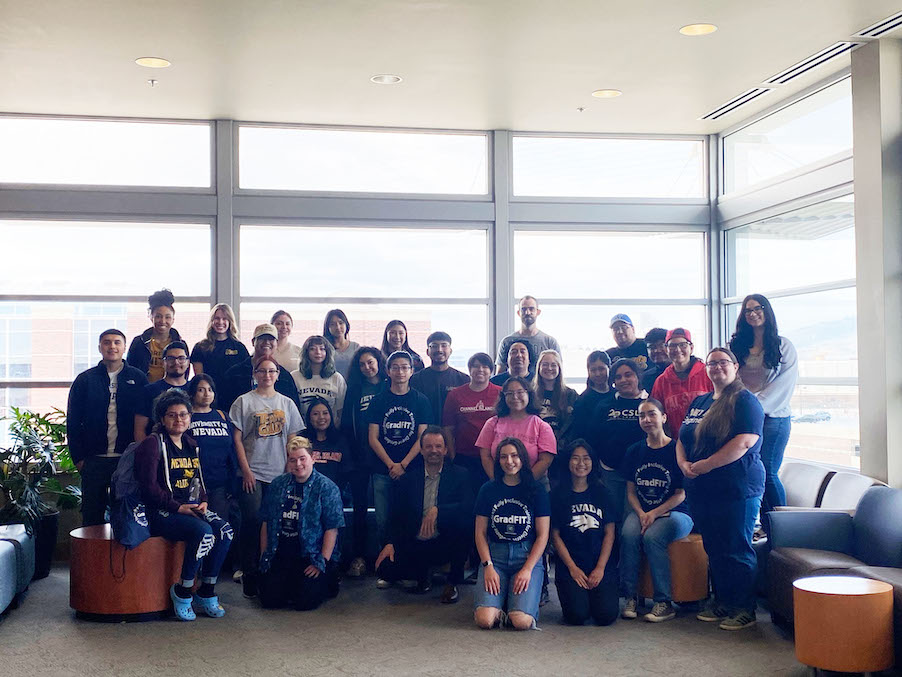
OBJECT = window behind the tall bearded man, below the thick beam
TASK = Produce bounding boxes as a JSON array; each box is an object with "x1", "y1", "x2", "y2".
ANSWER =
[{"x1": 514, "y1": 230, "x2": 708, "y2": 382}]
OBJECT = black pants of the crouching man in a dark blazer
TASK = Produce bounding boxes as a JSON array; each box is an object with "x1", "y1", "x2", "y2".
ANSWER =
[{"x1": 376, "y1": 530, "x2": 470, "y2": 585}]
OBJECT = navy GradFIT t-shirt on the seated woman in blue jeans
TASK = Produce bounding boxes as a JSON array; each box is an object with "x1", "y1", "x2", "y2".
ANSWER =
[{"x1": 620, "y1": 440, "x2": 688, "y2": 512}]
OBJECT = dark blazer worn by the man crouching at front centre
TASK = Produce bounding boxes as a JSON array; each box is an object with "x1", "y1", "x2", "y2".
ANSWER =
[{"x1": 389, "y1": 458, "x2": 474, "y2": 544}]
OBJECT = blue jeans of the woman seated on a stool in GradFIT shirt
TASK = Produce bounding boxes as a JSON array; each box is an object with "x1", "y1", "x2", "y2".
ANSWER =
[{"x1": 620, "y1": 510, "x2": 692, "y2": 602}]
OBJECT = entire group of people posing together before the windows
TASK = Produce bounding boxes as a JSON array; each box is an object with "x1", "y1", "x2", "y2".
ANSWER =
[{"x1": 68, "y1": 290, "x2": 797, "y2": 630}]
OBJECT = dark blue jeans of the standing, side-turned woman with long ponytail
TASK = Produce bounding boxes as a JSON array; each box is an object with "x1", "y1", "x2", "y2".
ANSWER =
[{"x1": 689, "y1": 493, "x2": 761, "y2": 614}]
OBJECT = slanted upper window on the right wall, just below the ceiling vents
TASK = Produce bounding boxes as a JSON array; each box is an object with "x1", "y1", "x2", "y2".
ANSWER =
[{"x1": 723, "y1": 78, "x2": 852, "y2": 193}]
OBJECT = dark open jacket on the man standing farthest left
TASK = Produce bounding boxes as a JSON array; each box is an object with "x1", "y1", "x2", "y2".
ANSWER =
[{"x1": 66, "y1": 361, "x2": 147, "y2": 463}]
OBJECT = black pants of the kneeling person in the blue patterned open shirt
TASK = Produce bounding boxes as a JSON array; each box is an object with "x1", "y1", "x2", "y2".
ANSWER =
[{"x1": 258, "y1": 551, "x2": 338, "y2": 611}]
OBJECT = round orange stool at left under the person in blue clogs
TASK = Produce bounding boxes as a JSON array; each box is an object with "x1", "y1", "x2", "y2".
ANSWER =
[{"x1": 69, "y1": 524, "x2": 185, "y2": 622}]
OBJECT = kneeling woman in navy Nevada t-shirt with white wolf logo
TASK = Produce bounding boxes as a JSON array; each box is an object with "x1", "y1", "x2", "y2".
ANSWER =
[{"x1": 551, "y1": 439, "x2": 620, "y2": 625}]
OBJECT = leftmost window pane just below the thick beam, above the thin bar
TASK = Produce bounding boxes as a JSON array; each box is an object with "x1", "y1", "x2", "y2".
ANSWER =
[{"x1": 0, "y1": 221, "x2": 212, "y2": 299}]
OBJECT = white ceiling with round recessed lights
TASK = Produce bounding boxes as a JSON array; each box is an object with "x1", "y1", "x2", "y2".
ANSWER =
[{"x1": 0, "y1": 0, "x2": 902, "y2": 134}]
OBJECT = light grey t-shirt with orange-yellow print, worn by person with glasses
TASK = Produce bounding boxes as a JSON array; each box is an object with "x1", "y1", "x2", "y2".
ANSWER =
[{"x1": 229, "y1": 390, "x2": 304, "y2": 482}]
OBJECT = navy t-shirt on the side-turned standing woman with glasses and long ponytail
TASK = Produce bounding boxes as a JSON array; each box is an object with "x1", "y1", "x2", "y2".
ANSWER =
[{"x1": 680, "y1": 390, "x2": 764, "y2": 501}]
